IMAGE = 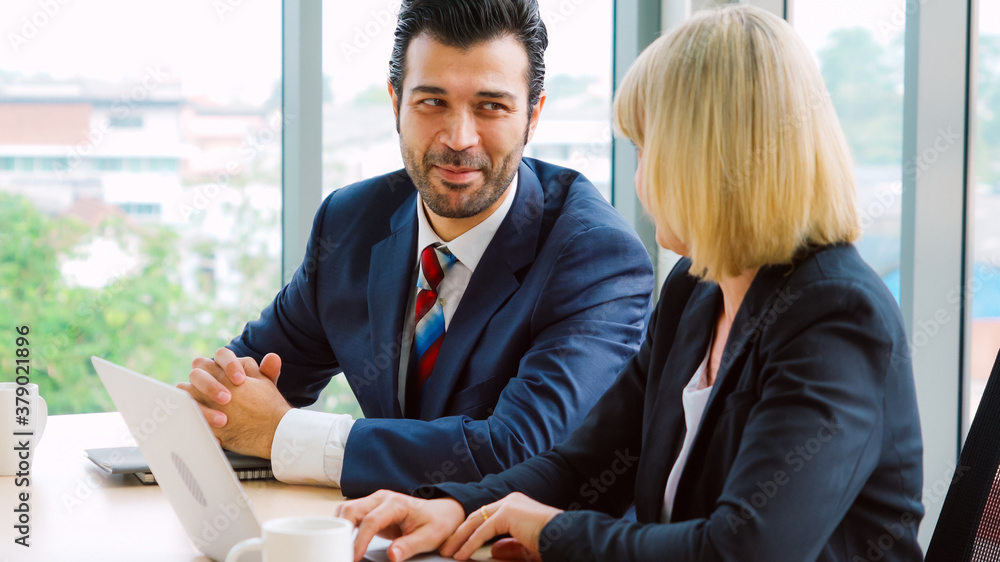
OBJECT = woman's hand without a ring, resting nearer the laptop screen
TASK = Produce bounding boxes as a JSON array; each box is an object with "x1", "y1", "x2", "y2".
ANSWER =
[{"x1": 334, "y1": 490, "x2": 465, "y2": 562}]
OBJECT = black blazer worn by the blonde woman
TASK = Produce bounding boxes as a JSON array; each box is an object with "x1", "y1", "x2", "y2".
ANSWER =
[{"x1": 434, "y1": 245, "x2": 923, "y2": 562}]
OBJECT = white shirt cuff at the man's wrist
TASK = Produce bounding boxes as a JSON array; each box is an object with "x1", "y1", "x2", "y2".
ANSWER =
[{"x1": 271, "y1": 409, "x2": 354, "y2": 488}]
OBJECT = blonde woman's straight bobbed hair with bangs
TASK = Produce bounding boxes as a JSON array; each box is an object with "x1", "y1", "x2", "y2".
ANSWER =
[{"x1": 614, "y1": 6, "x2": 860, "y2": 281}]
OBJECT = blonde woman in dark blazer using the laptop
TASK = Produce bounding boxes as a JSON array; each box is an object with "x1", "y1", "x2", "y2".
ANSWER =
[{"x1": 339, "y1": 6, "x2": 923, "y2": 561}]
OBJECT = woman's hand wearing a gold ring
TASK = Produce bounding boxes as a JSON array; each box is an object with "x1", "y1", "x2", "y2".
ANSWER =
[{"x1": 441, "y1": 492, "x2": 562, "y2": 560}]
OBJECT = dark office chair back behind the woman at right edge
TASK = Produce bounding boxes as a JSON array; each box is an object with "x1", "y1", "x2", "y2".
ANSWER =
[{"x1": 926, "y1": 344, "x2": 1000, "y2": 562}]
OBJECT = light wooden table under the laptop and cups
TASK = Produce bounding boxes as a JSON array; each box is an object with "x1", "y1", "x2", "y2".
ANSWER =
[{"x1": 0, "y1": 412, "x2": 489, "y2": 562}]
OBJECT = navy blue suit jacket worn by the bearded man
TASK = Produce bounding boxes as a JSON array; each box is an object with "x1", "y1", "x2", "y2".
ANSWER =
[{"x1": 230, "y1": 158, "x2": 653, "y2": 496}]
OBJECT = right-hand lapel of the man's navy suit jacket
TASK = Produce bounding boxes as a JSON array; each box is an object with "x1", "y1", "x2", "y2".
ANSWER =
[{"x1": 420, "y1": 162, "x2": 545, "y2": 420}]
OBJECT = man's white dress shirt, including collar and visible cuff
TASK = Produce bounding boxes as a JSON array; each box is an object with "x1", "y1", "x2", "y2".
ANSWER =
[{"x1": 271, "y1": 174, "x2": 518, "y2": 487}]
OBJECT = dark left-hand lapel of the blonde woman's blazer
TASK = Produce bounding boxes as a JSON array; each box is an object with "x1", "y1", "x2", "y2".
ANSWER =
[{"x1": 636, "y1": 283, "x2": 722, "y2": 522}]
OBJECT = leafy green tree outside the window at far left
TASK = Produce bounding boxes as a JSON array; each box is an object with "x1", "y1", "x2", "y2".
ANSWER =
[{"x1": 0, "y1": 193, "x2": 215, "y2": 414}]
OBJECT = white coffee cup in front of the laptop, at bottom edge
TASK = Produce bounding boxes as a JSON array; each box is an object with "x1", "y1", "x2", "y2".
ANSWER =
[{"x1": 226, "y1": 516, "x2": 354, "y2": 562}]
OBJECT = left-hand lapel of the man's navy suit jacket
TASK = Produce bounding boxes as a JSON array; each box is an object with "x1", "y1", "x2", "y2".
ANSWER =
[{"x1": 361, "y1": 191, "x2": 417, "y2": 418}]
